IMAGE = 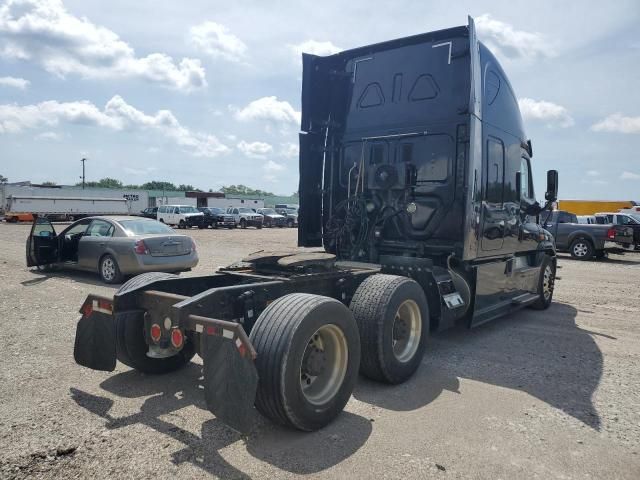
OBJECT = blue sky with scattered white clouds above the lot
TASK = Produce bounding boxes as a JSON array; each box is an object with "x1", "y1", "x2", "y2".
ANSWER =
[{"x1": 0, "y1": 0, "x2": 640, "y2": 200}]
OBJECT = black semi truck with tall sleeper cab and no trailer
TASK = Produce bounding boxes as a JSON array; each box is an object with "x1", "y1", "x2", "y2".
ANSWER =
[{"x1": 74, "y1": 19, "x2": 557, "y2": 431}]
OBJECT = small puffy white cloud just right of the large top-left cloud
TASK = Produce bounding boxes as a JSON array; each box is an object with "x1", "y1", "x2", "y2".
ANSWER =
[{"x1": 189, "y1": 22, "x2": 247, "y2": 62}]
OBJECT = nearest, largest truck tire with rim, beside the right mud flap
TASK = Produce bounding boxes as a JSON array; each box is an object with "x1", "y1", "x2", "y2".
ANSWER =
[{"x1": 250, "y1": 293, "x2": 360, "y2": 431}]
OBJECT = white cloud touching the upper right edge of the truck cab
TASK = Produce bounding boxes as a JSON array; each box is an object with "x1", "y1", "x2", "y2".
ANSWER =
[{"x1": 475, "y1": 13, "x2": 554, "y2": 59}]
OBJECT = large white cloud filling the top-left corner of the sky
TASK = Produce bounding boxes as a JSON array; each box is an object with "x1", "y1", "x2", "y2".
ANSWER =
[{"x1": 0, "y1": 0, "x2": 207, "y2": 91}]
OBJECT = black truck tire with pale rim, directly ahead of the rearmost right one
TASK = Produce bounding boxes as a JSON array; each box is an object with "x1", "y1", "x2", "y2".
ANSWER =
[{"x1": 350, "y1": 274, "x2": 429, "y2": 384}]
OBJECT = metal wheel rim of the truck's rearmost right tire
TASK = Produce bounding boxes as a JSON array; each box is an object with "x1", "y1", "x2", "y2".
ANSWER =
[{"x1": 300, "y1": 324, "x2": 349, "y2": 405}]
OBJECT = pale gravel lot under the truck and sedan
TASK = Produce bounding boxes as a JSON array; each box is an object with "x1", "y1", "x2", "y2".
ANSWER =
[{"x1": 0, "y1": 224, "x2": 640, "y2": 479}]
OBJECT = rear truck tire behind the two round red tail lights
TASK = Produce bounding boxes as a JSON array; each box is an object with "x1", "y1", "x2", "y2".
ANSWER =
[{"x1": 114, "y1": 272, "x2": 195, "y2": 374}]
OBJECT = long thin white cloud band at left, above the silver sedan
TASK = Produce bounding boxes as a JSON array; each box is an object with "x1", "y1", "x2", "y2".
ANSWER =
[{"x1": 0, "y1": 95, "x2": 229, "y2": 157}]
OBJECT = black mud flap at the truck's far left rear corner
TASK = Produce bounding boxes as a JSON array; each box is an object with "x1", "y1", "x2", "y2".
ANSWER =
[{"x1": 73, "y1": 295, "x2": 116, "y2": 372}]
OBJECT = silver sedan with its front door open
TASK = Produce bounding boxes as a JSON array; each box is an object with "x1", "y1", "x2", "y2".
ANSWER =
[{"x1": 27, "y1": 216, "x2": 198, "y2": 283}]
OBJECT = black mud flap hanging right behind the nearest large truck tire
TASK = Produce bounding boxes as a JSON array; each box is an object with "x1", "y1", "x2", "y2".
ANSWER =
[{"x1": 200, "y1": 320, "x2": 258, "y2": 434}]
